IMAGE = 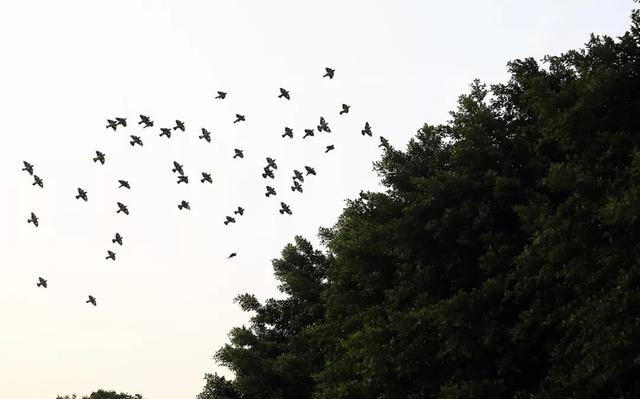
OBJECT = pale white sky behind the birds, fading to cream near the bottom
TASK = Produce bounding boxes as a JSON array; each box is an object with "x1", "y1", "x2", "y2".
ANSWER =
[{"x1": 0, "y1": 0, "x2": 634, "y2": 399}]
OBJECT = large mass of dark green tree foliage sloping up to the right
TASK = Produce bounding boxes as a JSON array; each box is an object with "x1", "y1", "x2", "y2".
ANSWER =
[{"x1": 199, "y1": 11, "x2": 640, "y2": 399}]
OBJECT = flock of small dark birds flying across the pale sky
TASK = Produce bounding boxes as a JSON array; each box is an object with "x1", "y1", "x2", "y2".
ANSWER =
[{"x1": 22, "y1": 68, "x2": 389, "y2": 306}]
